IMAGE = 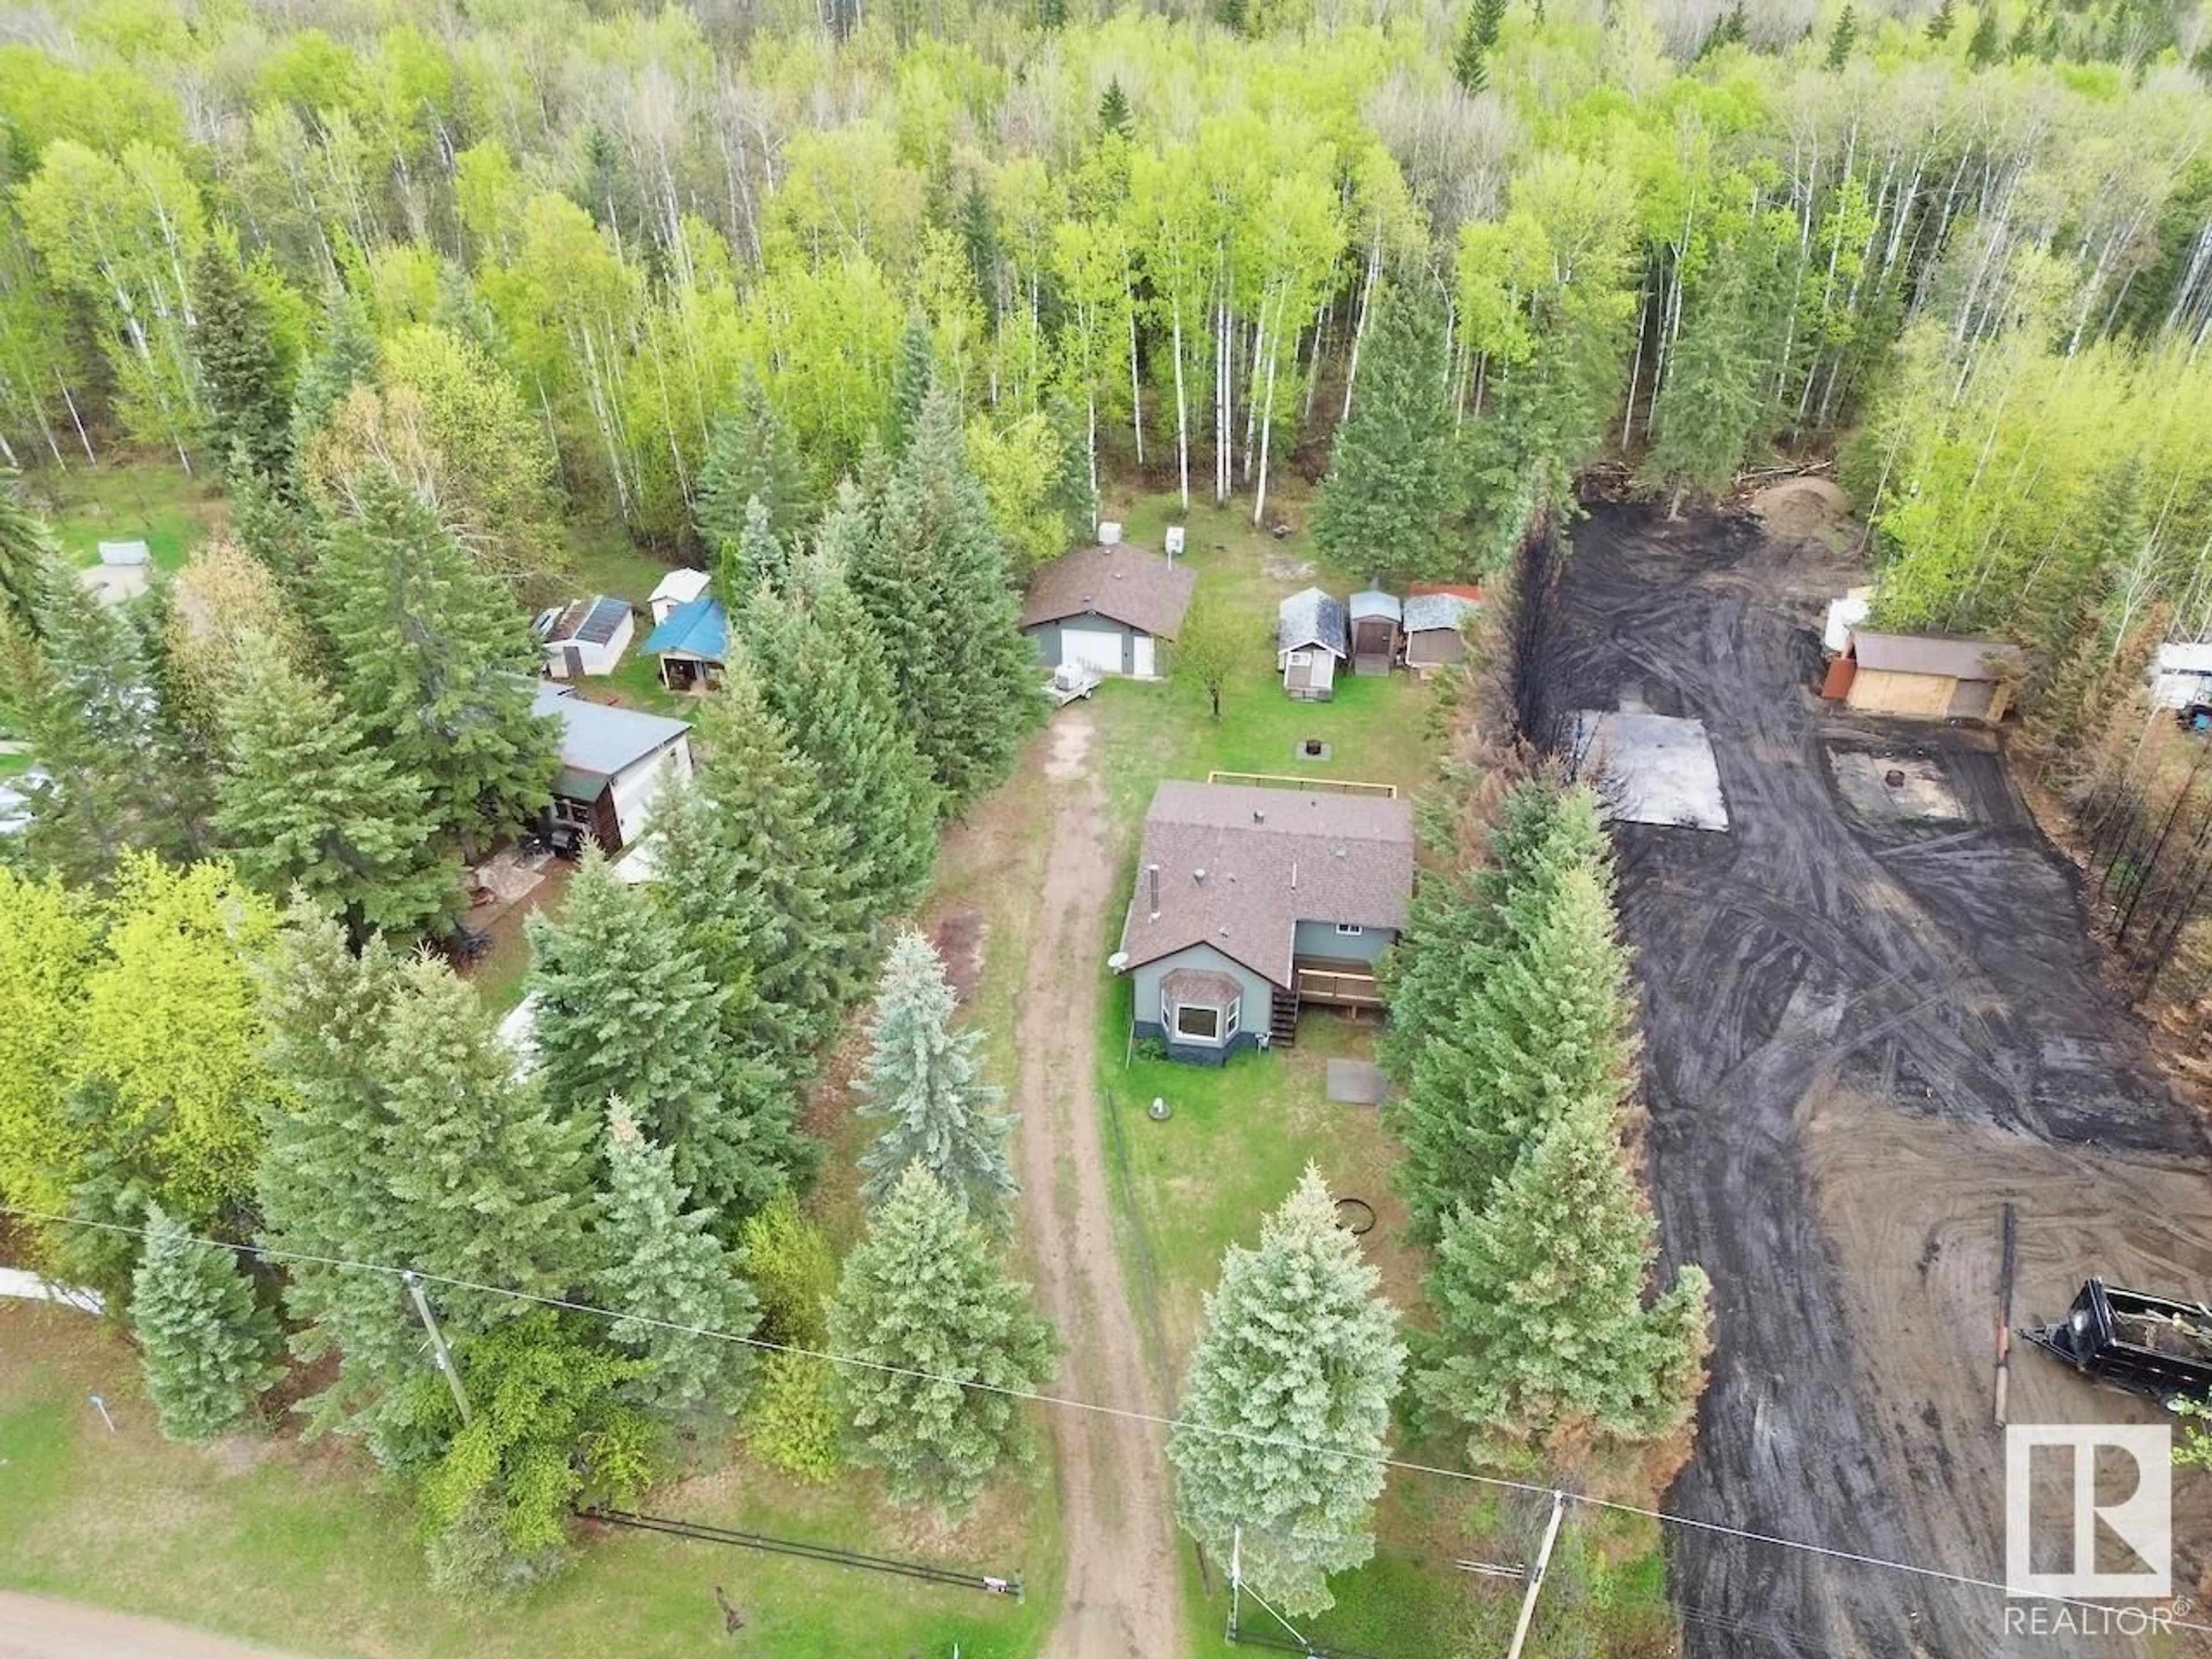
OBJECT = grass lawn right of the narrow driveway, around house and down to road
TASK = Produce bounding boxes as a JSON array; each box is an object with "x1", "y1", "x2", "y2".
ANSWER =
[{"x1": 1070, "y1": 487, "x2": 1675, "y2": 1659}]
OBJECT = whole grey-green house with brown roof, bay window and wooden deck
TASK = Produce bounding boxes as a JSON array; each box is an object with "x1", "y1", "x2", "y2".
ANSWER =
[{"x1": 1113, "y1": 781, "x2": 1414, "y2": 1066}]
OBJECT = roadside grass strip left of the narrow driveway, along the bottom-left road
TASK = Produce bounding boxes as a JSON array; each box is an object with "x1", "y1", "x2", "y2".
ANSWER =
[{"x1": 0, "y1": 1303, "x2": 1058, "y2": 1659}]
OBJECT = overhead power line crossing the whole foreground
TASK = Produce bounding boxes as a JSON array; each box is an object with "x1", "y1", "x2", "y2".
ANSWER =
[{"x1": 0, "y1": 1203, "x2": 2212, "y2": 1633}]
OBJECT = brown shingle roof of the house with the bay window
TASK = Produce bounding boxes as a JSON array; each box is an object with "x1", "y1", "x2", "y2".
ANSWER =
[{"x1": 1122, "y1": 781, "x2": 1414, "y2": 987}]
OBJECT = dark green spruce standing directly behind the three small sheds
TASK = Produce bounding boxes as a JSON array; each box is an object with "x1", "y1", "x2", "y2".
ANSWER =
[{"x1": 1314, "y1": 283, "x2": 1469, "y2": 593}]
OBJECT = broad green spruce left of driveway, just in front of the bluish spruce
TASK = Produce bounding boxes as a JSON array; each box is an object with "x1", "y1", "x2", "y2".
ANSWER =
[{"x1": 830, "y1": 1166, "x2": 1055, "y2": 1517}]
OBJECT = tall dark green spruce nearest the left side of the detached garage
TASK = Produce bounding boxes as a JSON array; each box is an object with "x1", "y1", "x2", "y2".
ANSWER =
[{"x1": 854, "y1": 387, "x2": 1042, "y2": 809}]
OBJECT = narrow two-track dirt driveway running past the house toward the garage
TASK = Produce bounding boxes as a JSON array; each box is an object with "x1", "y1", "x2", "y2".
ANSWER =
[{"x1": 1009, "y1": 710, "x2": 1181, "y2": 1659}]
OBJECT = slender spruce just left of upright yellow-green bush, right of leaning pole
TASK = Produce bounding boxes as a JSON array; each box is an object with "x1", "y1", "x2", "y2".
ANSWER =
[{"x1": 597, "y1": 1099, "x2": 761, "y2": 1416}]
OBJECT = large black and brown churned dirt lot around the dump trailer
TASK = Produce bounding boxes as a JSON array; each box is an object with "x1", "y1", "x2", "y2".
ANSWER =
[{"x1": 1531, "y1": 509, "x2": 2212, "y2": 1659}]
